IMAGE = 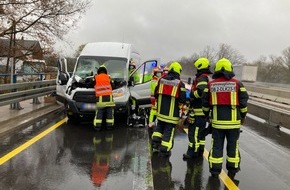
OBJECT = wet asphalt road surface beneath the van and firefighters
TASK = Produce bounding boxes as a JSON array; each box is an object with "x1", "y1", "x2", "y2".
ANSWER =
[{"x1": 0, "y1": 115, "x2": 290, "y2": 190}]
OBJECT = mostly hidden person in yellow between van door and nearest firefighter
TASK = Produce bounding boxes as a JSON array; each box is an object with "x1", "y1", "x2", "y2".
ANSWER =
[{"x1": 148, "y1": 67, "x2": 163, "y2": 128}]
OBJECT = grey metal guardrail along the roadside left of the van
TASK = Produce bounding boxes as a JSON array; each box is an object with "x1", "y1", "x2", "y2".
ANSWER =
[{"x1": 0, "y1": 80, "x2": 56, "y2": 106}]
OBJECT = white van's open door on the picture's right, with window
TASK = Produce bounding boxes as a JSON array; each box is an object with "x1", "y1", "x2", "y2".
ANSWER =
[{"x1": 129, "y1": 60, "x2": 158, "y2": 107}]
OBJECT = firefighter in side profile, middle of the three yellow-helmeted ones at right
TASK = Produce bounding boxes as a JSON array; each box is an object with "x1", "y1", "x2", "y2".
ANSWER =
[{"x1": 183, "y1": 57, "x2": 212, "y2": 159}]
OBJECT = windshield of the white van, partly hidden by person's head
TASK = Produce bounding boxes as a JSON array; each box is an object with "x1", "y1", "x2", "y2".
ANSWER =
[{"x1": 75, "y1": 56, "x2": 127, "y2": 80}]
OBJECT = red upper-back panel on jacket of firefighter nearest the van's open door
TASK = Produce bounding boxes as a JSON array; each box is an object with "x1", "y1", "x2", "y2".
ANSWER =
[{"x1": 157, "y1": 78, "x2": 180, "y2": 98}]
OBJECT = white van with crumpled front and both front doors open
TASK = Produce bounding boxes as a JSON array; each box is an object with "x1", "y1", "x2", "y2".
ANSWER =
[{"x1": 56, "y1": 42, "x2": 159, "y2": 120}]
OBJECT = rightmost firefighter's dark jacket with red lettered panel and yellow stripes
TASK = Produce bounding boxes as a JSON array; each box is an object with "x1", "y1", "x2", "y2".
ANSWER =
[{"x1": 202, "y1": 77, "x2": 249, "y2": 129}]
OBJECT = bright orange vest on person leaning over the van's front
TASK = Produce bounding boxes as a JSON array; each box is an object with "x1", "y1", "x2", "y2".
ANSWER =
[{"x1": 95, "y1": 73, "x2": 113, "y2": 97}]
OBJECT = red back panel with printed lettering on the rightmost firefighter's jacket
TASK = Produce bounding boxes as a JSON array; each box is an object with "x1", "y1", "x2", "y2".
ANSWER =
[{"x1": 209, "y1": 77, "x2": 240, "y2": 106}]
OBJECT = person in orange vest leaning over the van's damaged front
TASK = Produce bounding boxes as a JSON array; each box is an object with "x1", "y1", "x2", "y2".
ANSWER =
[{"x1": 94, "y1": 65, "x2": 115, "y2": 131}]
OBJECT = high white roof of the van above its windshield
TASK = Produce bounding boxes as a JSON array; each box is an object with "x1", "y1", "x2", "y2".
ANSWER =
[{"x1": 80, "y1": 42, "x2": 137, "y2": 58}]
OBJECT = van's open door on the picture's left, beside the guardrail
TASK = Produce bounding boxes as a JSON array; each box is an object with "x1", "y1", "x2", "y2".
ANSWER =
[{"x1": 56, "y1": 57, "x2": 70, "y2": 102}]
